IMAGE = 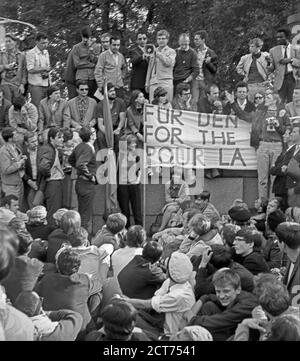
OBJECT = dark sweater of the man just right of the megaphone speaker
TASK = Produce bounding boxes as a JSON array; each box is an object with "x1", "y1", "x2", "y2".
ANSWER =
[{"x1": 173, "y1": 48, "x2": 199, "y2": 81}]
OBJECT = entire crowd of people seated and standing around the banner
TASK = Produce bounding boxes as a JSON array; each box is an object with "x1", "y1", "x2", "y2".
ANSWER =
[{"x1": 0, "y1": 24, "x2": 300, "y2": 341}]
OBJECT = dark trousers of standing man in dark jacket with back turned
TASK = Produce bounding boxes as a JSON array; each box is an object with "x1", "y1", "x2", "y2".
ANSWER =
[{"x1": 75, "y1": 178, "x2": 95, "y2": 233}]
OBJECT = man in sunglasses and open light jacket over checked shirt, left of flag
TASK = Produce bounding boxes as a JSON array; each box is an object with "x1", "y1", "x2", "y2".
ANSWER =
[{"x1": 63, "y1": 80, "x2": 97, "y2": 130}]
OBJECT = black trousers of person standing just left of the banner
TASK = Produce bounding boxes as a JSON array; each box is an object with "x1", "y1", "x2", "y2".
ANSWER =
[{"x1": 118, "y1": 184, "x2": 143, "y2": 228}]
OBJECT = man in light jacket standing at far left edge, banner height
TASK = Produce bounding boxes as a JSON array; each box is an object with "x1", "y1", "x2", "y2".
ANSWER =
[{"x1": 0, "y1": 127, "x2": 27, "y2": 202}]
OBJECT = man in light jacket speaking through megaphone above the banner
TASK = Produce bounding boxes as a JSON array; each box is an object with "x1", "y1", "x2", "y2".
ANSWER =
[{"x1": 146, "y1": 30, "x2": 176, "y2": 102}]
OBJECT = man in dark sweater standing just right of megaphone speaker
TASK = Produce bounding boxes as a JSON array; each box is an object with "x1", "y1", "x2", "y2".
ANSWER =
[{"x1": 173, "y1": 33, "x2": 199, "y2": 95}]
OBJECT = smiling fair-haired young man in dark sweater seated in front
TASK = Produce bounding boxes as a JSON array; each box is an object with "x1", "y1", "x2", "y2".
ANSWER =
[{"x1": 187, "y1": 268, "x2": 258, "y2": 341}]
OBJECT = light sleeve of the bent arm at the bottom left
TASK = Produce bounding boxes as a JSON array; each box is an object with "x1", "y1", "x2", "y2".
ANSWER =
[{"x1": 44, "y1": 310, "x2": 82, "y2": 341}]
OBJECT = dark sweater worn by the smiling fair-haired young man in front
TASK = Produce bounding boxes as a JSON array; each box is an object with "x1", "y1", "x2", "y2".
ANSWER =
[{"x1": 190, "y1": 291, "x2": 258, "y2": 341}]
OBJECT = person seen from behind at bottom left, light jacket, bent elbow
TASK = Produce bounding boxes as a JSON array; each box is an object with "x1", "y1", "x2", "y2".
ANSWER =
[{"x1": 15, "y1": 291, "x2": 82, "y2": 341}]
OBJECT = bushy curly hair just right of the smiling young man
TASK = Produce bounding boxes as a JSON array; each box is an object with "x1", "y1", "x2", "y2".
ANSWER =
[{"x1": 254, "y1": 273, "x2": 290, "y2": 317}]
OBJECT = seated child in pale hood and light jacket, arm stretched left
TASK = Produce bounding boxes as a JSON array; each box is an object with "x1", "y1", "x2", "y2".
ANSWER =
[{"x1": 117, "y1": 252, "x2": 195, "y2": 336}]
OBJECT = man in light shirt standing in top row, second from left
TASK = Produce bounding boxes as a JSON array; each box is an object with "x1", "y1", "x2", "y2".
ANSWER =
[{"x1": 26, "y1": 33, "x2": 50, "y2": 108}]
